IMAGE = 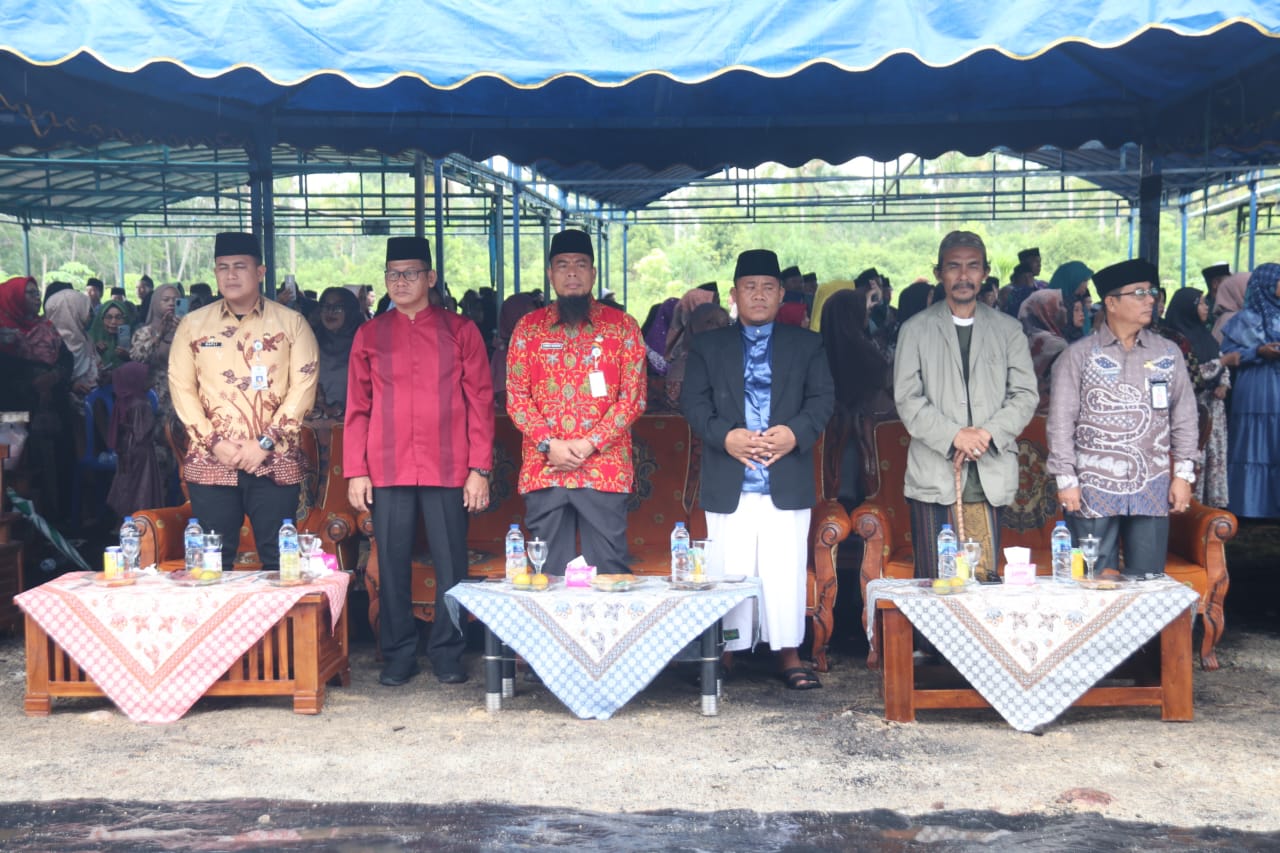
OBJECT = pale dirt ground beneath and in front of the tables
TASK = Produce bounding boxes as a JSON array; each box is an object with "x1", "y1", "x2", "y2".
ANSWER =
[{"x1": 0, "y1": 612, "x2": 1280, "y2": 831}]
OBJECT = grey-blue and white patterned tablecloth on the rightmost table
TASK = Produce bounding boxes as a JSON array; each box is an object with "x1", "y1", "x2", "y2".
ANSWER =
[{"x1": 867, "y1": 578, "x2": 1199, "y2": 731}]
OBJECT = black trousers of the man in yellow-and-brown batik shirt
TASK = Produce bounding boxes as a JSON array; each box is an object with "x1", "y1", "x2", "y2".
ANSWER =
[{"x1": 187, "y1": 471, "x2": 301, "y2": 571}]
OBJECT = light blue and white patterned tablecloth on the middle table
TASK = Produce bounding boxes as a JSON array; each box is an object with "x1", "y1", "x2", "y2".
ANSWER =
[{"x1": 444, "y1": 578, "x2": 759, "y2": 720}]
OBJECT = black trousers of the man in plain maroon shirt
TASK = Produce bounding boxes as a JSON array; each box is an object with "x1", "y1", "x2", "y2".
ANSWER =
[{"x1": 372, "y1": 485, "x2": 467, "y2": 675}]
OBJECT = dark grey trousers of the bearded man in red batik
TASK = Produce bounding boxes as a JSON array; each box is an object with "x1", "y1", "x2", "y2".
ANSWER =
[{"x1": 525, "y1": 485, "x2": 631, "y2": 575}]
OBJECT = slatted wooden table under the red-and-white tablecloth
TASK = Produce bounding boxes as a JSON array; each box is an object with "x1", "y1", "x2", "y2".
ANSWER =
[{"x1": 23, "y1": 592, "x2": 351, "y2": 716}]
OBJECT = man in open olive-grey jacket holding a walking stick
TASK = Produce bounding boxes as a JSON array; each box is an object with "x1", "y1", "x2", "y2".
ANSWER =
[{"x1": 893, "y1": 231, "x2": 1039, "y2": 579}]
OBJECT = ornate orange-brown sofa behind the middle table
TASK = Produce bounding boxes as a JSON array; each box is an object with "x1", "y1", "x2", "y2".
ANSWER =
[{"x1": 358, "y1": 414, "x2": 850, "y2": 672}]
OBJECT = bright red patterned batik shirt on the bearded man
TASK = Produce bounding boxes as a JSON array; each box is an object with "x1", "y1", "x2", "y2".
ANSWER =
[{"x1": 507, "y1": 300, "x2": 645, "y2": 494}]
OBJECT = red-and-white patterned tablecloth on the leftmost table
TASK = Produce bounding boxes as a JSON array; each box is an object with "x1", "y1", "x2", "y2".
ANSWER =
[{"x1": 14, "y1": 571, "x2": 349, "y2": 722}]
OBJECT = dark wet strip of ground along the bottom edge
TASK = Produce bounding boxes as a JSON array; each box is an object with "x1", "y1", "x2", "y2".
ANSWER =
[{"x1": 0, "y1": 799, "x2": 1280, "y2": 853}]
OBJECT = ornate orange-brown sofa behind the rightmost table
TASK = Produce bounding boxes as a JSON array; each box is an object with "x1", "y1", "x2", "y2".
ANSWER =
[{"x1": 850, "y1": 415, "x2": 1236, "y2": 670}]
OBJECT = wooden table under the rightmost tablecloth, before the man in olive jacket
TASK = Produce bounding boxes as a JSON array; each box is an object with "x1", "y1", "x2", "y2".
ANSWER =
[{"x1": 876, "y1": 599, "x2": 1194, "y2": 722}]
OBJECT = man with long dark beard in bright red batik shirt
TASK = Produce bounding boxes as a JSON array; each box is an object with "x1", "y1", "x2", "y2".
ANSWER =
[{"x1": 507, "y1": 229, "x2": 645, "y2": 574}]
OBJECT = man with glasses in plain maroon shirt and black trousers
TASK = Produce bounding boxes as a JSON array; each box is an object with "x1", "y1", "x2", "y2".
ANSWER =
[{"x1": 343, "y1": 237, "x2": 493, "y2": 686}]
